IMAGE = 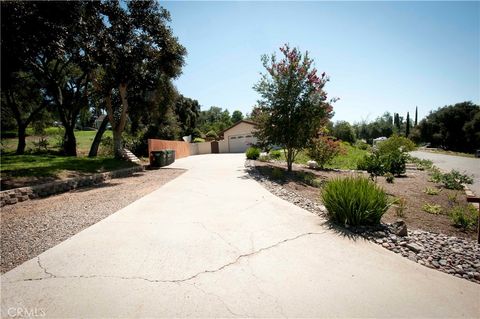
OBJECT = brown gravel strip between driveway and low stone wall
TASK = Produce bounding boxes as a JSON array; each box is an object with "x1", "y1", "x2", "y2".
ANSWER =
[{"x1": 0, "y1": 168, "x2": 184, "y2": 273}]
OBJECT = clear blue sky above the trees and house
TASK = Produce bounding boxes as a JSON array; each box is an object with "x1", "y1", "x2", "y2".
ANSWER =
[{"x1": 161, "y1": 2, "x2": 480, "y2": 122}]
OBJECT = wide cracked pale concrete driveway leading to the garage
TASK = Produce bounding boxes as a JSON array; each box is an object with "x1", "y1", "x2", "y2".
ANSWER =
[{"x1": 1, "y1": 154, "x2": 480, "y2": 318}]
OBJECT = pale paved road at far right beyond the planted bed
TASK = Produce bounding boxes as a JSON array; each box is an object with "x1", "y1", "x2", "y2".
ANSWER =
[{"x1": 410, "y1": 151, "x2": 480, "y2": 196}]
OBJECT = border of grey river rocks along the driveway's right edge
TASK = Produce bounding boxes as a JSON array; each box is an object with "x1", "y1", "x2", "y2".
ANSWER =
[{"x1": 245, "y1": 161, "x2": 480, "y2": 284}]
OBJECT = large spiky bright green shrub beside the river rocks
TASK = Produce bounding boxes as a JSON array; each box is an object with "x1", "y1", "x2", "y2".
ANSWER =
[{"x1": 321, "y1": 176, "x2": 390, "y2": 226}]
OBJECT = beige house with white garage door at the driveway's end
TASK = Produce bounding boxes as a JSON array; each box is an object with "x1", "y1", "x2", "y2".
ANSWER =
[{"x1": 220, "y1": 120, "x2": 257, "y2": 153}]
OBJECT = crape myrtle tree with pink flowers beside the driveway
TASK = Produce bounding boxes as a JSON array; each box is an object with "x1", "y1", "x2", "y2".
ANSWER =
[{"x1": 254, "y1": 44, "x2": 336, "y2": 172}]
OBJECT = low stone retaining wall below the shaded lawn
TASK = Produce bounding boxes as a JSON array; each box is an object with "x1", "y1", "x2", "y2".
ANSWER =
[{"x1": 0, "y1": 166, "x2": 145, "y2": 207}]
